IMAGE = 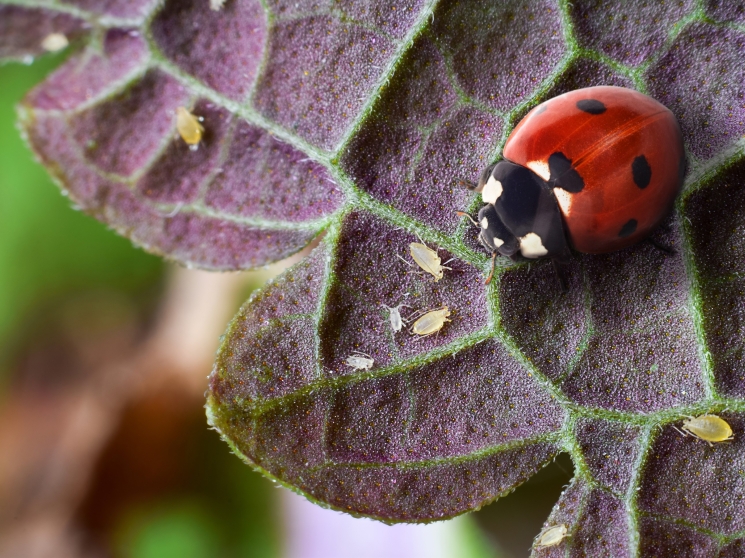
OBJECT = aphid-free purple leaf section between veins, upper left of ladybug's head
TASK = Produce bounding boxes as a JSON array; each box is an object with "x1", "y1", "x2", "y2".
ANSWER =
[{"x1": 341, "y1": 38, "x2": 502, "y2": 232}]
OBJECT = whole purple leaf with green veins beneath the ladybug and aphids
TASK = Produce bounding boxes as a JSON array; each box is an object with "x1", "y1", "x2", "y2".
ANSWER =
[{"x1": 0, "y1": 0, "x2": 745, "y2": 557}]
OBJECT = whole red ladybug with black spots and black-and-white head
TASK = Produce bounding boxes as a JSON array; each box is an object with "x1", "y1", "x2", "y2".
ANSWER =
[{"x1": 458, "y1": 86, "x2": 686, "y2": 290}]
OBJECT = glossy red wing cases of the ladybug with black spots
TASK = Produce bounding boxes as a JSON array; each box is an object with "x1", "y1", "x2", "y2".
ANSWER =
[{"x1": 503, "y1": 86, "x2": 685, "y2": 253}]
